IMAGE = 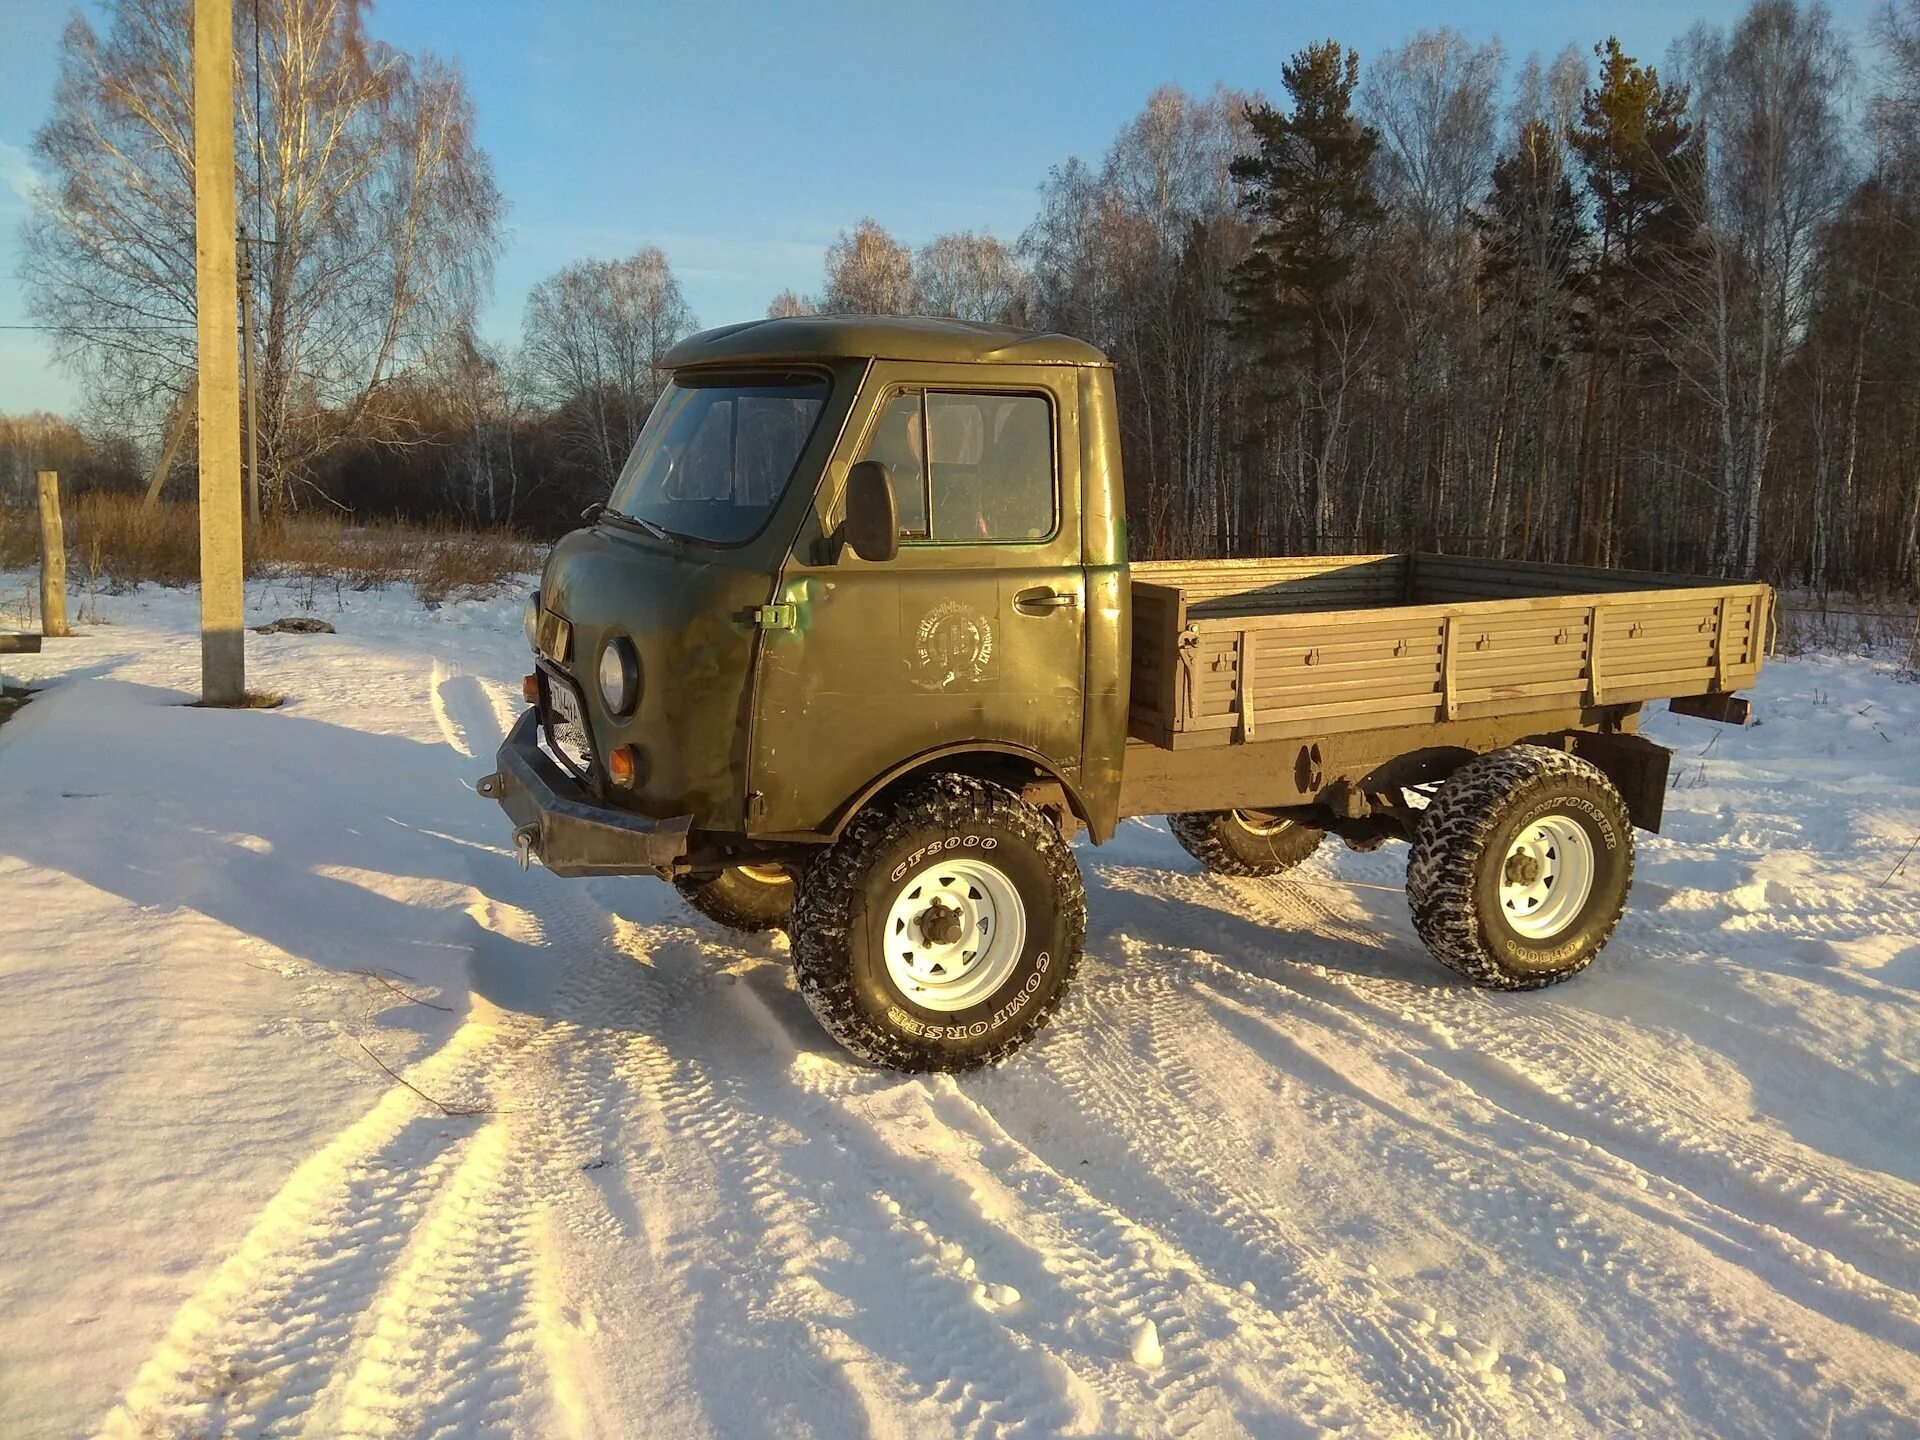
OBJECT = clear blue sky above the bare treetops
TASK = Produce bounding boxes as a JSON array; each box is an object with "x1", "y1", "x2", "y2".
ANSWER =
[{"x1": 0, "y1": 0, "x2": 1880, "y2": 413}]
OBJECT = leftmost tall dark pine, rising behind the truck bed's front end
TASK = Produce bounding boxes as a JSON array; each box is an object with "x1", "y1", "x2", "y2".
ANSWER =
[{"x1": 1233, "y1": 40, "x2": 1386, "y2": 543}]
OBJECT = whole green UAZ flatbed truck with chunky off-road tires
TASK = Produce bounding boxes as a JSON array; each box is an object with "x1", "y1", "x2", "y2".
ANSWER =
[{"x1": 480, "y1": 317, "x2": 1772, "y2": 1069}]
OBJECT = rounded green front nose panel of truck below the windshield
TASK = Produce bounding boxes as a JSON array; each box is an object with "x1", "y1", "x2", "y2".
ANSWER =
[{"x1": 540, "y1": 524, "x2": 774, "y2": 831}]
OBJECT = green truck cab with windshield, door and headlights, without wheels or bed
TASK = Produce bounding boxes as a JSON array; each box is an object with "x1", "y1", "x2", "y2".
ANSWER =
[{"x1": 487, "y1": 317, "x2": 1129, "y2": 874}]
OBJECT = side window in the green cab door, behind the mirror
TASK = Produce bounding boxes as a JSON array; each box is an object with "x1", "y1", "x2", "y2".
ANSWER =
[{"x1": 862, "y1": 390, "x2": 1058, "y2": 545}]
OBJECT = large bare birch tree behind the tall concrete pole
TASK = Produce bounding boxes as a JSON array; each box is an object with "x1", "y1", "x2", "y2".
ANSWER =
[{"x1": 23, "y1": 0, "x2": 503, "y2": 505}]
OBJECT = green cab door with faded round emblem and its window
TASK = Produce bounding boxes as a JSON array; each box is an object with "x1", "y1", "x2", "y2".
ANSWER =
[{"x1": 749, "y1": 361, "x2": 1087, "y2": 835}]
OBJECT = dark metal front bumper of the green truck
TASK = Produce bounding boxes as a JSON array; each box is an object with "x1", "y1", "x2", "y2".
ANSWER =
[{"x1": 476, "y1": 710, "x2": 693, "y2": 876}]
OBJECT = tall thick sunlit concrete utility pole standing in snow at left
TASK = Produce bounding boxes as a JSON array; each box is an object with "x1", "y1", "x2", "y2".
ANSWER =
[{"x1": 194, "y1": 0, "x2": 246, "y2": 705}]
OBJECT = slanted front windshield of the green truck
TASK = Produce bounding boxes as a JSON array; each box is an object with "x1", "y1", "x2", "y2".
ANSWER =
[{"x1": 607, "y1": 374, "x2": 828, "y2": 545}]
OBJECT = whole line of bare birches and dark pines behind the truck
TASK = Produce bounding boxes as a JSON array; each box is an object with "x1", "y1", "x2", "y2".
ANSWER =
[{"x1": 0, "y1": 0, "x2": 1920, "y2": 591}]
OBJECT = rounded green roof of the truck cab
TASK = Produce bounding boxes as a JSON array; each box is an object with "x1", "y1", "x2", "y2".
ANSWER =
[{"x1": 662, "y1": 315, "x2": 1108, "y2": 371}]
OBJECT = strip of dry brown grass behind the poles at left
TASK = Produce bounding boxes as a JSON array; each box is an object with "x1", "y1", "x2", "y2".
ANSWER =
[{"x1": 0, "y1": 493, "x2": 538, "y2": 607}]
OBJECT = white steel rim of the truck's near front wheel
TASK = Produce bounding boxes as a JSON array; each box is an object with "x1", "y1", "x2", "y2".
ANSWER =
[{"x1": 881, "y1": 856, "x2": 1027, "y2": 1014}]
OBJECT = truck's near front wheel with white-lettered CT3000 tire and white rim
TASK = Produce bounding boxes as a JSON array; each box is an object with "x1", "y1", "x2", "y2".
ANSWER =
[{"x1": 793, "y1": 776, "x2": 1087, "y2": 1071}]
